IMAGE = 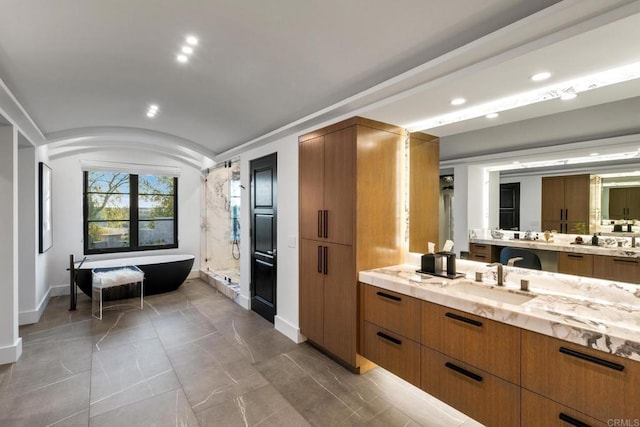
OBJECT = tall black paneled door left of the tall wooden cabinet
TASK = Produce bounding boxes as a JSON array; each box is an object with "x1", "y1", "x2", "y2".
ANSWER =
[{"x1": 250, "y1": 153, "x2": 278, "y2": 323}]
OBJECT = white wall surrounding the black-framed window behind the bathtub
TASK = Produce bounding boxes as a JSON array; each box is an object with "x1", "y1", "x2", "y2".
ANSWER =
[{"x1": 49, "y1": 149, "x2": 201, "y2": 295}]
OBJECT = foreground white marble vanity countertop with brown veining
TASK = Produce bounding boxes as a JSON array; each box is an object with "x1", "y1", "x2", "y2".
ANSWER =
[{"x1": 359, "y1": 260, "x2": 640, "y2": 361}]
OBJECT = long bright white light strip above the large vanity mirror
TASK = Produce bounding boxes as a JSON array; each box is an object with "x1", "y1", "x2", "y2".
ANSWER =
[{"x1": 403, "y1": 62, "x2": 640, "y2": 132}]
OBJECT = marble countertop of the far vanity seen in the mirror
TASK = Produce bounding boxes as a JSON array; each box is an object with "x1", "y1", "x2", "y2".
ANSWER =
[{"x1": 469, "y1": 238, "x2": 640, "y2": 258}]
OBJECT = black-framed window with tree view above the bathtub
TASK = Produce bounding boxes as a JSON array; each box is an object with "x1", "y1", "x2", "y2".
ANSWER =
[{"x1": 84, "y1": 171, "x2": 178, "y2": 254}]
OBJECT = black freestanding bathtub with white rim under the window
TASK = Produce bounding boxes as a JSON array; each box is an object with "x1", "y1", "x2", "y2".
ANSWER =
[{"x1": 75, "y1": 255, "x2": 195, "y2": 299}]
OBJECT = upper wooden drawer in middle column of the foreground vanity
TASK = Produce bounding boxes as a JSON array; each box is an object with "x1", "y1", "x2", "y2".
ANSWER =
[{"x1": 421, "y1": 301, "x2": 520, "y2": 384}]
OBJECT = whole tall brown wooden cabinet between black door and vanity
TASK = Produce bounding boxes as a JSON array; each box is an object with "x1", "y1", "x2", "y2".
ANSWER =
[{"x1": 298, "y1": 117, "x2": 412, "y2": 370}]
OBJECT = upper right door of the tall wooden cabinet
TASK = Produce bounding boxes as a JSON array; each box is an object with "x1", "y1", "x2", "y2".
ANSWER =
[{"x1": 324, "y1": 126, "x2": 356, "y2": 245}]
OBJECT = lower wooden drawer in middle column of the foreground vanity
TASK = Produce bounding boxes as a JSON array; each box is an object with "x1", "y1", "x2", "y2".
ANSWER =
[{"x1": 422, "y1": 346, "x2": 520, "y2": 427}]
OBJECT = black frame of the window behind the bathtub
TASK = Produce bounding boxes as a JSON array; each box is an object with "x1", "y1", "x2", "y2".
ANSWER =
[{"x1": 82, "y1": 170, "x2": 178, "y2": 255}]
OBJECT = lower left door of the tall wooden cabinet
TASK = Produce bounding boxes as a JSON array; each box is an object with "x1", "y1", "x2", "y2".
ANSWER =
[{"x1": 299, "y1": 239, "x2": 324, "y2": 345}]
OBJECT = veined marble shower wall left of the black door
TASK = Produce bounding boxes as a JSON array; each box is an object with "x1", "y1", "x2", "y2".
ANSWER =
[{"x1": 202, "y1": 161, "x2": 240, "y2": 281}]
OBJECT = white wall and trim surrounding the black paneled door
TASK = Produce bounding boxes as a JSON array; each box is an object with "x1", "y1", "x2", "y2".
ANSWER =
[{"x1": 240, "y1": 135, "x2": 305, "y2": 342}]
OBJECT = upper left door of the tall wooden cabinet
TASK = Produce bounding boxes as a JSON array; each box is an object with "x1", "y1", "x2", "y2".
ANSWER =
[{"x1": 298, "y1": 137, "x2": 324, "y2": 240}]
